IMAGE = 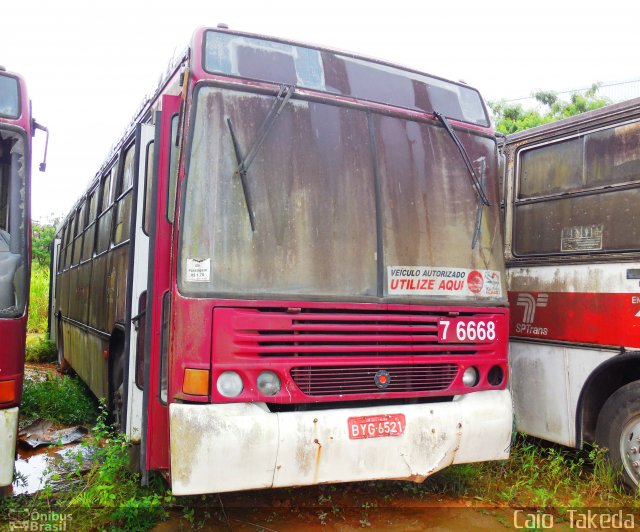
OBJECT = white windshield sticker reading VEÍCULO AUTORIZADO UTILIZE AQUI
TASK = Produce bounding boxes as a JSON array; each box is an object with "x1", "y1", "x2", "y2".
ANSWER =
[{"x1": 387, "y1": 266, "x2": 502, "y2": 297}]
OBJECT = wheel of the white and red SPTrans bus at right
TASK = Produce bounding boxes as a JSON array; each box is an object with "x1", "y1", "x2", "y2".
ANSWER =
[{"x1": 596, "y1": 381, "x2": 640, "y2": 492}]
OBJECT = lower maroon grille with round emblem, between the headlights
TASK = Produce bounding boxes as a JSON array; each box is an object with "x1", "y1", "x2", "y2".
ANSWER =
[{"x1": 291, "y1": 364, "x2": 458, "y2": 396}]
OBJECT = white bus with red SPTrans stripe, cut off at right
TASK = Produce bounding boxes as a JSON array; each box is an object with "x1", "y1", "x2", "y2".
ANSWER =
[{"x1": 504, "y1": 99, "x2": 640, "y2": 487}]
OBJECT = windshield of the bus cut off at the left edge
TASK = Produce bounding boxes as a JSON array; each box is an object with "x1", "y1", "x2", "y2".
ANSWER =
[{"x1": 0, "y1": 129, "x2": 27, "y2": 317}]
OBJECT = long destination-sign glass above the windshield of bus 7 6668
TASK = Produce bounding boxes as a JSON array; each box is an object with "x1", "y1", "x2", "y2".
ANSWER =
[{"x1": 203, "y1": 31, "x2": 489, "y2": 126}]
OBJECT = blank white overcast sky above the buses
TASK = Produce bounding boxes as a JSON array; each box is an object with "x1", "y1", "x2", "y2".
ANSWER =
[{"x1": 5, "y1": 0, "x2": 640, "y2": 220}]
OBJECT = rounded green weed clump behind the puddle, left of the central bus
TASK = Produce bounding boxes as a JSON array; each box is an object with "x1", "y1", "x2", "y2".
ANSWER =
[{"x1": 20, "y1": 375, "x2": 98, "y2": 425}]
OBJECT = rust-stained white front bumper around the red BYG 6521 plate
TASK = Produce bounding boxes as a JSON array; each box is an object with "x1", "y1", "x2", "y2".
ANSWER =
[{"x1": 169, "y1": 390, "x2": 513, "y2": 495}]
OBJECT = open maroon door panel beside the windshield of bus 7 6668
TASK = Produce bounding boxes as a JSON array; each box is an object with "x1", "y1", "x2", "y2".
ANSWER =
[{"x1": 141, "y1": 95, "x2": 180, "y2": 481}]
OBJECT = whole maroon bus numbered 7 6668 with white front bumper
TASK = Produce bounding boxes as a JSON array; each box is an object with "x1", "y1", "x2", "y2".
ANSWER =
[{"x1": 52, "y1": 28, "x2": 512, "y2": 495}]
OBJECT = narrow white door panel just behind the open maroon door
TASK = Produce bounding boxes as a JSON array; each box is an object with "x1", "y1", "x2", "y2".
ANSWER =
[{"x1": 126, "y1": 124, "x2": 155, "y2": 443}]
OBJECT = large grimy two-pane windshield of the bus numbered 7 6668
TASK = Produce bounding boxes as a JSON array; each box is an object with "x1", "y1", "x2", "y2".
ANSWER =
[{"x1": 179, "y1": 85, "x2": 503, "y2": 299}]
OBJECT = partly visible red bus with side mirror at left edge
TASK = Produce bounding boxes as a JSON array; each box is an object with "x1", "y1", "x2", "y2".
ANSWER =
[{"x1": 0, "y1": 67, "x2": 46, "y2": 490}]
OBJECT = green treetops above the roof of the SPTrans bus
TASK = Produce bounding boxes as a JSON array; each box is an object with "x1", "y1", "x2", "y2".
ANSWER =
[{"x1": 489, "y1": 83, "x2": 611, "y2": 135}]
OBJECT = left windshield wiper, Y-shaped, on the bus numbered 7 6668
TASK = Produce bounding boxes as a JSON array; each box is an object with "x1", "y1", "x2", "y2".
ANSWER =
[{"x1": 227, "y1": 85, "x2": 295, "y2": 231}]
